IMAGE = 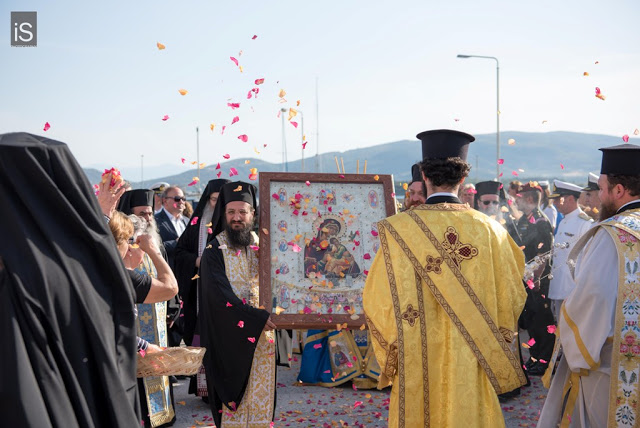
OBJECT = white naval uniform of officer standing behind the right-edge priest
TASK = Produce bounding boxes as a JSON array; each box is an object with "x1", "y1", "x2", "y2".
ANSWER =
[{"x1": 549, "y1": 208, "x2": 593, "y2": 321}]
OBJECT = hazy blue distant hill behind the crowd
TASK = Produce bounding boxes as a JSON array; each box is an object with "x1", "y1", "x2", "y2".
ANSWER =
[{"x1": 85, "y1": 131, "x2": 622, "y2": 193}]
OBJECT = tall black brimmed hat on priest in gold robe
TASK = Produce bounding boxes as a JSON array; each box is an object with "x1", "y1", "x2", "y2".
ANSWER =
[{"x1": 416, "y1": 129, "x2": 475, "y2": 161}]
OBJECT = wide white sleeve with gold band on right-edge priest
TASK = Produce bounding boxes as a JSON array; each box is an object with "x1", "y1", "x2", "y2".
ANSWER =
[{"x1": 558, "y1": 228, "x2": 619, "y2": 372}]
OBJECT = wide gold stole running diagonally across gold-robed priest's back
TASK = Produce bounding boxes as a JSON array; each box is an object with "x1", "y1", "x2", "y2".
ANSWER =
[{"x1": 378, "y1": 210, "x2": 526, "y2": 394}]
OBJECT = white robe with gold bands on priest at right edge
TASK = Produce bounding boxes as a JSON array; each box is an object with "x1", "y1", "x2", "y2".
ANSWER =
[{"x1": 538, "y1": 226, "x2": 619, "y2": 428}]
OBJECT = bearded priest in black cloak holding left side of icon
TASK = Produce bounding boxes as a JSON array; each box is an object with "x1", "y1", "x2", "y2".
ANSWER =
[{"x1": 198, "y1": 181, "x2": 276, "y2": 428}]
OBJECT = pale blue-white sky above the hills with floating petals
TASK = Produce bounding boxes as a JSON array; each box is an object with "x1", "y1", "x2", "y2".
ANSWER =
[{"x1": 0, "y1": 0, "x2": 640, "y2": 177}]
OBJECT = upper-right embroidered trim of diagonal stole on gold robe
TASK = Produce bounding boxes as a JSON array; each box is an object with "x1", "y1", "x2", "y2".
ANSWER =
[{"x1": 407, "y1": 211, "x2": 527, "y2": 388}]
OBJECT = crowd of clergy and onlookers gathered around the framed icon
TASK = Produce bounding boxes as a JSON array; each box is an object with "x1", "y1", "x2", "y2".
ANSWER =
[{"x1": 0, "y1": 130, "x2": 640, "y2": 428}]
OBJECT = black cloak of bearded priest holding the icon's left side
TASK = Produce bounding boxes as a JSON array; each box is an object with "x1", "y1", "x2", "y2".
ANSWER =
[{"x1": 198, "y1": 239, "x2": 275, "y2": 427}]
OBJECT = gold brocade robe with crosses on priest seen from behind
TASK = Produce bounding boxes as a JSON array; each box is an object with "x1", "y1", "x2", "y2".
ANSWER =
[{"x1": 363, "y1": 204, "x2": 526, "y2": 428}]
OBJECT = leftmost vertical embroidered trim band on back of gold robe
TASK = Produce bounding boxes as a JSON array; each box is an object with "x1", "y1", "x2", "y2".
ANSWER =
[{"x1": 378, "y1": 226, "x2": 405, "y2": 428}]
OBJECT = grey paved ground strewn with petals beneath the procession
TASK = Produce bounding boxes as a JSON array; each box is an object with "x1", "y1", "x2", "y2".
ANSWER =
[{"x1": 169, "y1": 337, "x2": 546, "y2": 428}]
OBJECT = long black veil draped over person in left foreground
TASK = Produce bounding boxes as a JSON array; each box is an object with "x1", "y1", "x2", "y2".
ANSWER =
[{"x1": 0, "y1": 132, "x2": 141, "y2": 427}]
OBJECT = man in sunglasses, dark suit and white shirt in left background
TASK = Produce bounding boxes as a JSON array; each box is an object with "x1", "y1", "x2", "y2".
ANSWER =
[{"x1": 155, "y1": 186, "x2": 189, "y2": 270}]
